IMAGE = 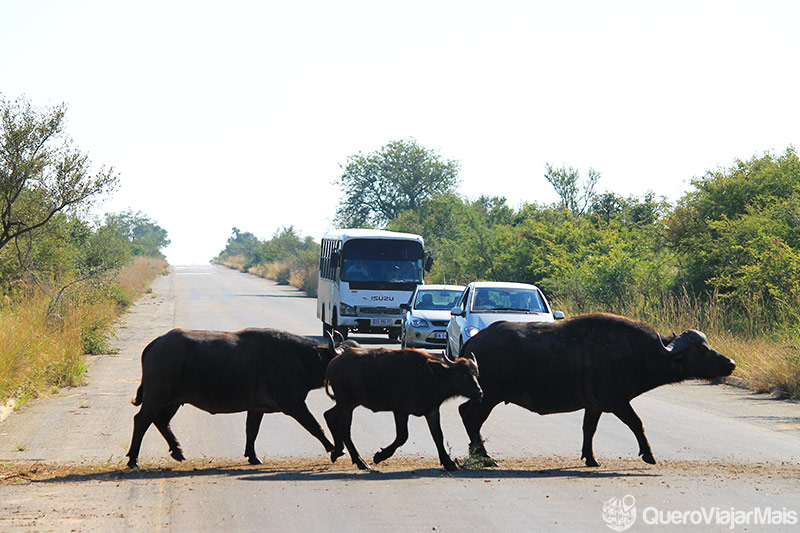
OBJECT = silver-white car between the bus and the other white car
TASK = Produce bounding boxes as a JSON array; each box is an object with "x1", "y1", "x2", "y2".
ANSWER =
[{"x1": 400, "y1": 285, "x2": 464, "y2": 349}]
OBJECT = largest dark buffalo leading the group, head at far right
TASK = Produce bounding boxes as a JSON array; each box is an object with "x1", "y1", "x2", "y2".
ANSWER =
[{"x1": 459, "y1": 314, "x2": 736, "y2": 466}]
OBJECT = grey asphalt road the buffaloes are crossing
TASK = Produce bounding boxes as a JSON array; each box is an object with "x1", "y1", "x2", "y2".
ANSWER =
[{"x1": 0, "y1": 267, "x2": 800, "y2": 531}]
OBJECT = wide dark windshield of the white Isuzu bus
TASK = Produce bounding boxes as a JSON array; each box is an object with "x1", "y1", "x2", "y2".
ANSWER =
[{"x1": 342, "y1": 239, "x2": 423, "y2": 283}]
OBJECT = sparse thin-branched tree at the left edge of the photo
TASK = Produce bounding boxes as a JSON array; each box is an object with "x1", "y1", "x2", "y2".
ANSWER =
[{"x1": 0, "y1": 96, "x2": 117, "y2": 249}]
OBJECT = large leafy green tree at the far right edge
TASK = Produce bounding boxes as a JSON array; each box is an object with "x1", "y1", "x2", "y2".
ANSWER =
[{"x1": 667, "y1": 147, "x2": 800, "y2": 294}]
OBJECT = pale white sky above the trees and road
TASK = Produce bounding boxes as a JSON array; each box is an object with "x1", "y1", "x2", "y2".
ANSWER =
[{"x1": 0, "y1": 0, "x2": 800, "y2": 264}]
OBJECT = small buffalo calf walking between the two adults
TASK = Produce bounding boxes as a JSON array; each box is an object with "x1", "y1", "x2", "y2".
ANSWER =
[{"x1": 325, "y1": 348, "x2": 481, "y2": 470}]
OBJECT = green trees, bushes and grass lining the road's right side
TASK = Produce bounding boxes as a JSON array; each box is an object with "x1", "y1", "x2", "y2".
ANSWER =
[{"x1": 218, "y1": 140, "x2": 800, "y2": 398}]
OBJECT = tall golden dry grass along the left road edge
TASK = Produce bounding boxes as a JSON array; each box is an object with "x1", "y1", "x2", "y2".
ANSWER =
[{"x1": 0, "y1": 258, "x2": 166, "y2": 406}]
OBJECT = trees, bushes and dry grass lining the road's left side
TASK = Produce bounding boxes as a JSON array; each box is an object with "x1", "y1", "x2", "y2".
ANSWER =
[{"x1": 0, "y1": 95, "x2": 169, "y2": 405}]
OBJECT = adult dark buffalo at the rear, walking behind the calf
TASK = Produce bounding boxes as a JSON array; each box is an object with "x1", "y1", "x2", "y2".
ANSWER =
[{"x1": 128, "y1": 329, "x2": 341, "y2": 468}]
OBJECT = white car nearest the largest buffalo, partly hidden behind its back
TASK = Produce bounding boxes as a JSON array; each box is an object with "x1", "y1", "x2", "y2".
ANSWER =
[{"x1": 446, "y1": 281, "x2": 564, "y2": 358}]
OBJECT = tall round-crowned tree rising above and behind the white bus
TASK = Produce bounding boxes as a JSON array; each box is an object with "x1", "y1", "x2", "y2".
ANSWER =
[{"x1": 335, "y1": 139, "x2": 459, "y2": 227}]
